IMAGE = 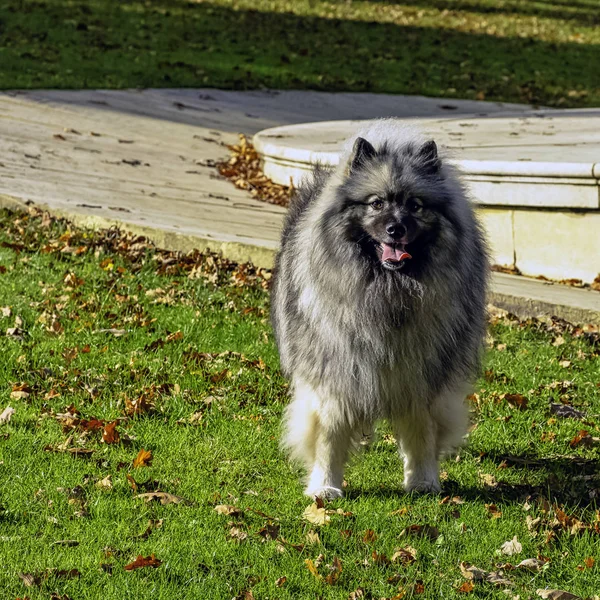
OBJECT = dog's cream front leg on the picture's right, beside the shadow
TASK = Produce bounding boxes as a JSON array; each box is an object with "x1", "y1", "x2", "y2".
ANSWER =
[{"x1": 393, "y1": 412, "x2": 441, "y2": 493}]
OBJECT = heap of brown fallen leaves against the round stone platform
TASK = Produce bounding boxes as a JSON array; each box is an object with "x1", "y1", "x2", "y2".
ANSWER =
[{"x1": 216, "y1": 134, "x2": 294, "y2": 207}]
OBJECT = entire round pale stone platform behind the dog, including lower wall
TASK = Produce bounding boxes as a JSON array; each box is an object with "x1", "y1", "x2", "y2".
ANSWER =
[{"x1": 253, "y1": 119, "x2": 600, "y2": 282}]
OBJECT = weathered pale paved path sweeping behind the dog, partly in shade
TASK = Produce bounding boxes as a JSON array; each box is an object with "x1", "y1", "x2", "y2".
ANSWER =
[{"x1": 0, "y1": 89, "x2": 600, "y2": 323}]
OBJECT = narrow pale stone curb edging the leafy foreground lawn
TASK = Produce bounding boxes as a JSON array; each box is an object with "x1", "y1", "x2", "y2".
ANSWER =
[{"x1": 0, "y1": 194, "x2": 600, "y2": 326}]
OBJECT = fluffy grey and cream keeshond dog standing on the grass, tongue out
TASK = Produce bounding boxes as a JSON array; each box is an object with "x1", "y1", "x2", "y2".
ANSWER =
[{"x1": 271, "y1": 120, "x2": 488, "y2": 498}]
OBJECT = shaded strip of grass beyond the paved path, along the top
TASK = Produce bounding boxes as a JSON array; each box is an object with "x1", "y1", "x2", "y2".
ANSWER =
[{"x1": 0, "y1": 0, "x2": 600, "y2": 106}]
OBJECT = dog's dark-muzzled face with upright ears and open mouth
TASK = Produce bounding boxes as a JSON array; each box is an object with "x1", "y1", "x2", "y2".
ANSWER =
[{"x1": 340, "y1": 138, "x2": 441, "y2": 272}]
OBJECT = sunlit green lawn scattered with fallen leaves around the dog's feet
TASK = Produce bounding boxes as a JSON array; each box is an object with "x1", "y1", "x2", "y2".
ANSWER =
[{"x1": 0, "y1": 211, "x2": 600, "y2": 600}]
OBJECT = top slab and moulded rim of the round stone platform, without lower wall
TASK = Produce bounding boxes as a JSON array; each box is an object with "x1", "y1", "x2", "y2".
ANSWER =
[{"x1": 253, "y1": 117, "x2": 600, "y2": 209}]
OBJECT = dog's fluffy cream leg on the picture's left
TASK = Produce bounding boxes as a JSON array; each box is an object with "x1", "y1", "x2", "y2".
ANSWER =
[{"x1": 283, "y1": 382, "x2": 352, "y2": 498}]
